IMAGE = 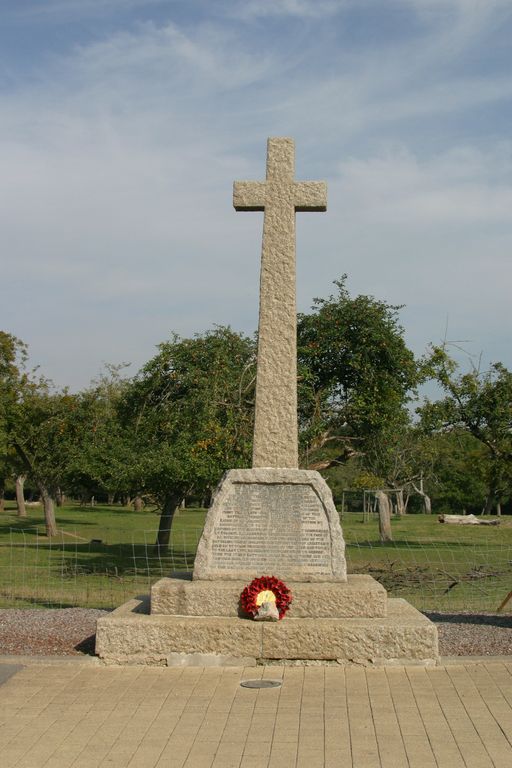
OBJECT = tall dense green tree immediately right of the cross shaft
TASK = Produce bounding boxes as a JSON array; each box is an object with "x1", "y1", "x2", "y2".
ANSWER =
[{"x1": 298, "y1": 276, "x2": 419, "y2": 468}]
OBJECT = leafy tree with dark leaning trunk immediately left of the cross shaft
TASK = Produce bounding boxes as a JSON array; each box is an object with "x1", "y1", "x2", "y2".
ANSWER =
[{"x1": 121, "y1": 327, "x2": 255, "y2": 552}]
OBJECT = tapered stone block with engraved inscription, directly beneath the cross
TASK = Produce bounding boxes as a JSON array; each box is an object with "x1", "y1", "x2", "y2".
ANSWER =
[{"x1": 194, "y1": 468, "x2": 347, "y2": 581}]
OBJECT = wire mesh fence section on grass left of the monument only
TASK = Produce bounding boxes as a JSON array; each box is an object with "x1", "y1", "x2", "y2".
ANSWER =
[{"x1": 0, "y1": 528, "x2": 206, "y2": 608}]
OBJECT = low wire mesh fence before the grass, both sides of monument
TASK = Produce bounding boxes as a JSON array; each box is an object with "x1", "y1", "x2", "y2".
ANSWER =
[{"x1": 0, "y1": 526, "x2": 512, "y2": 613}]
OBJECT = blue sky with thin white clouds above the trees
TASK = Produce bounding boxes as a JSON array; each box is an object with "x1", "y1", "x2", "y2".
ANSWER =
[{"x1": 0, "y1": 0, "x2": 512, "y2": 391}]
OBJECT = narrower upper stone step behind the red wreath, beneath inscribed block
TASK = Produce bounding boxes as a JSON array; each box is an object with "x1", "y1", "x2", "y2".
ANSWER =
[{"x1": 151, "y1": 574, "x2": 387, "y2": 618}]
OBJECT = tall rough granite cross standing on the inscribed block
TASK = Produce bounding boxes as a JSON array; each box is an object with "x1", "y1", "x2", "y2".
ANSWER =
[{"x1": 233, "y1": 138, "x2": 327, "y2": 468}]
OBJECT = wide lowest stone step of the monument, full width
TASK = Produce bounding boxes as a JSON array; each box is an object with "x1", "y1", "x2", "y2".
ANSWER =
[{"x1": 96, "y1": 598, "x2": 439, "y2": 664}]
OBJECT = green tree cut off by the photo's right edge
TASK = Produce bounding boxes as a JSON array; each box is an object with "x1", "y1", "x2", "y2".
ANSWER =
[{"x1": 418, "y1": 346, "x2": 512, "y2": 514}]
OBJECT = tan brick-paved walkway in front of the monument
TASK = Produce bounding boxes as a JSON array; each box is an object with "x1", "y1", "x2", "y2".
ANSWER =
[{"x1": 0, "y1": 662, "x2": 512, "y2": 768}]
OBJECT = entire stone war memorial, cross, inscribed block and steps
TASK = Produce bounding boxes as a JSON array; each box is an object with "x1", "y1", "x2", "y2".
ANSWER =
[{"x1": 96, "y1": 138, "x2": 438, "y2": 665}]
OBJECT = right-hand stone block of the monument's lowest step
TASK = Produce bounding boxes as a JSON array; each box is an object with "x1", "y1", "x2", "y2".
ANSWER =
[{"x1": 262, "y1": 599, "x2": 439, "y2": 663}]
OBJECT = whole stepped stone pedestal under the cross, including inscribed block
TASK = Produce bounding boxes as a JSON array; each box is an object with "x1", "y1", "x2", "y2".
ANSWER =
[{"x1": 96, "y1": 468, "x2": 438, "y2": 666}]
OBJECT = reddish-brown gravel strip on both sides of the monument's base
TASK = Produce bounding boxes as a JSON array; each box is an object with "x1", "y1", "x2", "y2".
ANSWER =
[{"x1": 0, "y1": 608, "x2": 512, "y2": 656}]
